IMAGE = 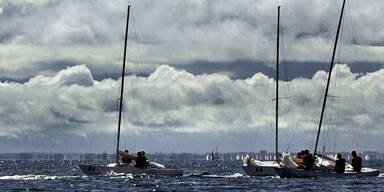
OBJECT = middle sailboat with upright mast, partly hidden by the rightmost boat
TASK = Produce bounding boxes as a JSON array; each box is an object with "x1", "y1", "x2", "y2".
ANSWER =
[{"x1": 243, "y1": 6, "x2": 281, "y2": 176}]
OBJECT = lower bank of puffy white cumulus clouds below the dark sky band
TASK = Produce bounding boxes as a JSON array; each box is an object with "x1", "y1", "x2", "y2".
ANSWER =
[{"x1": 0, "y1": 65, "x2": 384, "y2": 151}]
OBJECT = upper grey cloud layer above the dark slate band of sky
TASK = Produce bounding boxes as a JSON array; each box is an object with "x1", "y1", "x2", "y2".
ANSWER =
[{"x1": 0, "y1": 0, "x2": 384, "y2": 79}]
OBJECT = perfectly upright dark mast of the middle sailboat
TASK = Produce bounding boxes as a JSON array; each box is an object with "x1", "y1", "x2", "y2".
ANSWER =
[{"x1": 275, "y1": 6, "x2": 281, "y2": 161}]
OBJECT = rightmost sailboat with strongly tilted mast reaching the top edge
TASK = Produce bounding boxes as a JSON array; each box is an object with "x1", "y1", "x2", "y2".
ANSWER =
[{"x1": 275, "y1": 0, "x2": 379, "y2": 178}]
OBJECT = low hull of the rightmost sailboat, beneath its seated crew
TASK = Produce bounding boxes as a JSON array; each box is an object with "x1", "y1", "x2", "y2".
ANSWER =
[{"x1": 275, "y1": 167, "x2": 379, "y2": 178}]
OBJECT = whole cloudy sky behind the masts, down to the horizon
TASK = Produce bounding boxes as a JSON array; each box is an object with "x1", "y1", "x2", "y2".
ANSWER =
[{"x1": 0, "y1": 0, "x2": 384, "y2": 153}]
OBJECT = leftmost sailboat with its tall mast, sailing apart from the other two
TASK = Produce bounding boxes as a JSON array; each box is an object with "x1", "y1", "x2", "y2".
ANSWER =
[{"x1": 79, "y1": 4, "x2": 183, "y2": 176}]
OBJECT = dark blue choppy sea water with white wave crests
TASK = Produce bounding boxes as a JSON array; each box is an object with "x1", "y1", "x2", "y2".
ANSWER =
[{"x1": 0, "y1": 161, "x2": 384, "y2": 191}]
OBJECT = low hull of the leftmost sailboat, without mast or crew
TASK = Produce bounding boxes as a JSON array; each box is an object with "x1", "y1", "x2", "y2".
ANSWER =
[{"x1": 79, "y1": 164, "x2": 184, "y2": 176}]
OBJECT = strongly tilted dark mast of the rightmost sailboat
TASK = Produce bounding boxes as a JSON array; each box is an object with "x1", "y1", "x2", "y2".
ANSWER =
[{"x1": 313, "y1": 0, "x2": 345, "y2": 155}]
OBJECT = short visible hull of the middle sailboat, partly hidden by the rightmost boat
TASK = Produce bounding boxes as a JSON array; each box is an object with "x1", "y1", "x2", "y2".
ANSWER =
[{"x1": 243, "y1": 156, "x2": 279, "y2": 176}]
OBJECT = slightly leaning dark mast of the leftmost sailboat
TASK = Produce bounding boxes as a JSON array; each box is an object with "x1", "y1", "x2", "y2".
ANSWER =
[{"x1": 116, "y1": 4, "x2": 131, "y2": 162}]
